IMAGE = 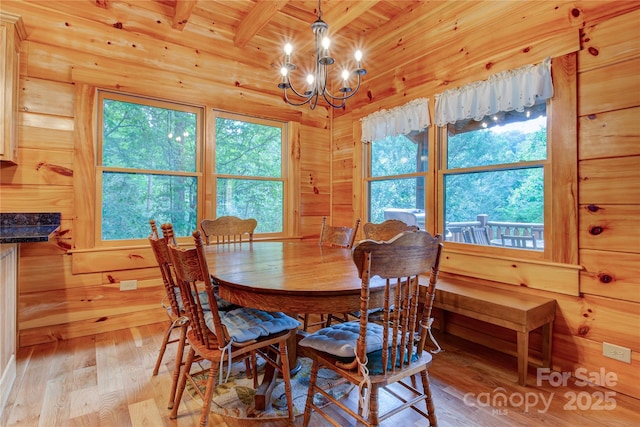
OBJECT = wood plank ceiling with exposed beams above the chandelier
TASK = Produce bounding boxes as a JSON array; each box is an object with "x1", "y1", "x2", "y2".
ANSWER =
[{"x1": 22, "y1": 0, "x2": 424, "y2": 95}]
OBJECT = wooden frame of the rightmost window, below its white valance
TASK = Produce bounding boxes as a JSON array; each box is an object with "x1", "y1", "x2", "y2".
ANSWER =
[{"x1": 435, "y1": 52, "x2": 579, "y2": 266}]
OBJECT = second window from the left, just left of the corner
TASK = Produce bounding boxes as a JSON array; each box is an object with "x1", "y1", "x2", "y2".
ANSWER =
[{"x1": 215, "y1": 114, "x2": 287, "y2": 234}]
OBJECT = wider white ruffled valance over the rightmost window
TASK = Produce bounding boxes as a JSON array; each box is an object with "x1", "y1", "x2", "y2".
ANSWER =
[{"x1": 434, "y1": 58, "x2": 553, "y2": 126}]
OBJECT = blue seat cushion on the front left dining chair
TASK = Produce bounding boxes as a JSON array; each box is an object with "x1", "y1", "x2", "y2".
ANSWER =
[{"x1": 205, "y1": 307, "x2": 301, "y2": 342}]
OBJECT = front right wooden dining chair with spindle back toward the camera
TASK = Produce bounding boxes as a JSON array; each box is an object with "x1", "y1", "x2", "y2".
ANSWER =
[{"x1": 299, "y1": 231, "x2": 443, "y2": 426}]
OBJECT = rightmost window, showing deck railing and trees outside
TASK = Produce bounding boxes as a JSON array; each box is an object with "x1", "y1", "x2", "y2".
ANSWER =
[{"x1": 441, "y1": 101, "x2": 547, "y2": 250}]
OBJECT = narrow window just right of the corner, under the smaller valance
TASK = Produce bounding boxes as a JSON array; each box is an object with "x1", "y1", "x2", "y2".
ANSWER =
[{"x1": 365, "y1": 131, "x2": 428, "y2": 228}]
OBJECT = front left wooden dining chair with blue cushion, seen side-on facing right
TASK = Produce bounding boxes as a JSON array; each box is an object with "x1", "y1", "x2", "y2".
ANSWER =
[{"x1": 162, "y1": 224, "x2": 300, "y2": 427}]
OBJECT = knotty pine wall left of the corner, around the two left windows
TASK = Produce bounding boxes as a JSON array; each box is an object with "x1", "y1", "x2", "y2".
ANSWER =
[{"x1": 0, "y1": 2, "x2": 331, "y2": 346}]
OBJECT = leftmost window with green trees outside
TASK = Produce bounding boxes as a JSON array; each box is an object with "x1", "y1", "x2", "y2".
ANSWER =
[{"x1": 96, "y1": 92, "x2": 203, "y2": 243}]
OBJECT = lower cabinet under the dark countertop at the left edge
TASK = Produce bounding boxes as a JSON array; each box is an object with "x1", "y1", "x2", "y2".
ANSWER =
[{"x1": 0, "y1": 243, "x2": 18, "y2": 414}]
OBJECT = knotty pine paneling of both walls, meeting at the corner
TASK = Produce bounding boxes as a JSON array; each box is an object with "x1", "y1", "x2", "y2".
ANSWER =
[{"x1": 0, "y1": 1, "x2": 640, "y2": 404}]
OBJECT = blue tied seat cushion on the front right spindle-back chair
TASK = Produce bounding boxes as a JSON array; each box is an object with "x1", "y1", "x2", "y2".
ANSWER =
[{"x1": 299, "y1": 321, "x2": 391, "y2": 358}]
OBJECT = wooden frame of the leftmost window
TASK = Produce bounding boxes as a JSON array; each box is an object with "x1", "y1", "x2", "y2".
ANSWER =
[{"x1": 94, "y1": 89, "x2": 205, "y2": 247}]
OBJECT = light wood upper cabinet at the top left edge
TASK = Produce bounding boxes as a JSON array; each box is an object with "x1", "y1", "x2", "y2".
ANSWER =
[{"x1": 0, "y1": 12, "x2": 26, "y2": 163}]
